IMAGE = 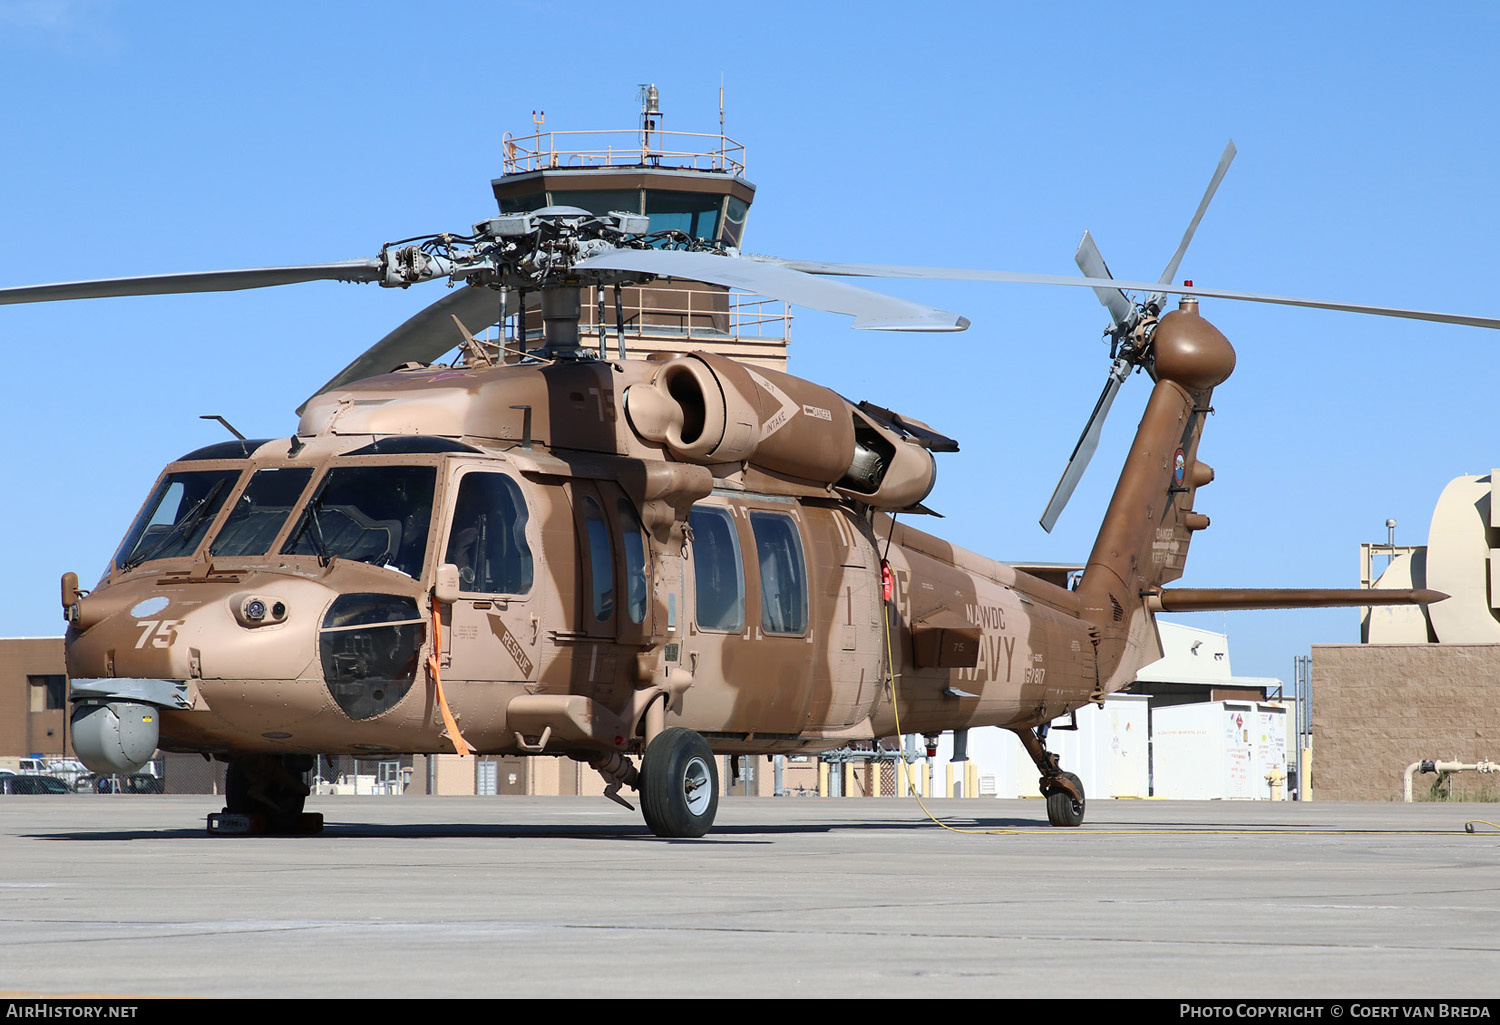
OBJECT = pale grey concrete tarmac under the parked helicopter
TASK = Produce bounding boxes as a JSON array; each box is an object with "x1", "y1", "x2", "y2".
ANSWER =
[{"x1": 0, "y1": 794, "x2": 1500, "y2": 1001}]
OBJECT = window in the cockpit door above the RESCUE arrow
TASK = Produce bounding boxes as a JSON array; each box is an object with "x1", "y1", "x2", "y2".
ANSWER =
[{"x1": 443, "y1": 473, "x2": 533, "y2": 594}]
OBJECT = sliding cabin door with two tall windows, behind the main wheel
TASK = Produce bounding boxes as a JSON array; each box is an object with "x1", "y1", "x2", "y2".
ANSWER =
[{"x1": 684, "y1": 498, "x2": 813, "y2": 737}]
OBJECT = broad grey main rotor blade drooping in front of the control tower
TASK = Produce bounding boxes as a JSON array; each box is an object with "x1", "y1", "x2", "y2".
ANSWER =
[{"x1": 573, "y1": 249, "x2": 969, "y2": 332}]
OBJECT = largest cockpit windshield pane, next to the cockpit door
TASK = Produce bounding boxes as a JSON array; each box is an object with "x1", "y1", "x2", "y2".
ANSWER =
[{"x1": 282, "y1": 465, "x2": 438, "y2": 576}]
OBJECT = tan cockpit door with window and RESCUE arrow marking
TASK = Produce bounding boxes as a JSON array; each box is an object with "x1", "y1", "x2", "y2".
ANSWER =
[{"x1": 443, "y1": 468, "x2": 542, "y2": 681}]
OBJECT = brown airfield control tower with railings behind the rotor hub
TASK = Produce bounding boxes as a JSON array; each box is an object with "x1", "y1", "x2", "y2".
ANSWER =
[{"x1": 492, "y1": 86, "x2": 792, "y2": 371}]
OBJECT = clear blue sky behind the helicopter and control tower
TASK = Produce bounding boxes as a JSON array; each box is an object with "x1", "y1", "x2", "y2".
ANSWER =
[{"x1": 0, "y1": 0, "x2": 1500, "y2": 690}]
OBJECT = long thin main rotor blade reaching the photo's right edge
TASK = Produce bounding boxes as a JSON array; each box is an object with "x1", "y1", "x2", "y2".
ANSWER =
[{"x1": 774, "y1": 257, "x2": 1500, "y2": 330}]
